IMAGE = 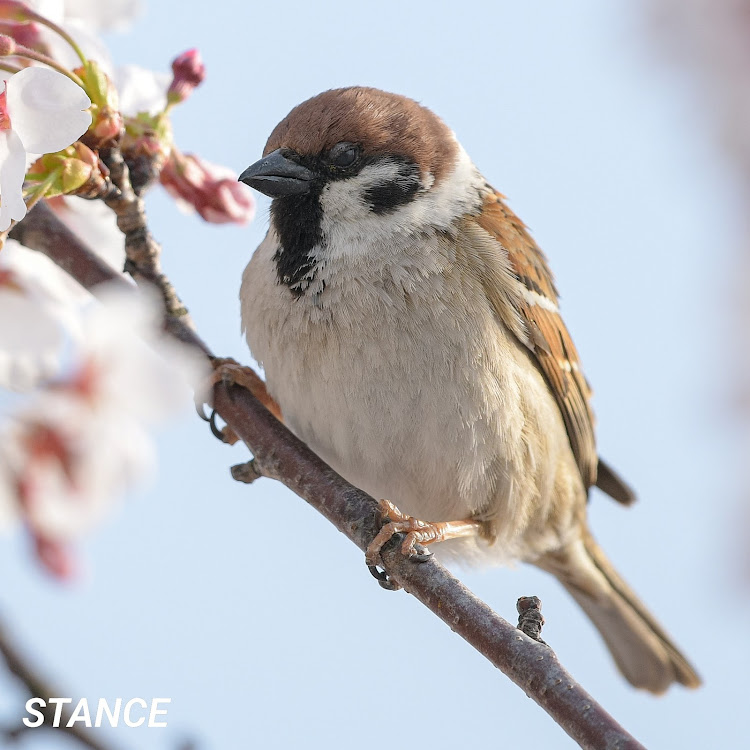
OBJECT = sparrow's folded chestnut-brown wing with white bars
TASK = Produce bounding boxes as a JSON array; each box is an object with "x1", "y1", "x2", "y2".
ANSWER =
[{"x1": 475, "y1": 192, "x2": 598, "y2": 487}]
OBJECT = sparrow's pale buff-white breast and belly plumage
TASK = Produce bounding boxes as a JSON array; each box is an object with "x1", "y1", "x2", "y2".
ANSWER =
[{"x1": 241, "y1": 145, "x2": 582, "y2": 562}]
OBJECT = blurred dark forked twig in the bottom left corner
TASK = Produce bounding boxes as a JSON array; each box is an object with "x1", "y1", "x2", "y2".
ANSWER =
[{"x1": 0, "y1": 622, "x2": 119, "y2": 750}]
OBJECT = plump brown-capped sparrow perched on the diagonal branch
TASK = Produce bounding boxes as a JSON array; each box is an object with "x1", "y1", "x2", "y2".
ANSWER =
[{"x1": 240, "y1": 87, "x2": 700, "y2": 694}]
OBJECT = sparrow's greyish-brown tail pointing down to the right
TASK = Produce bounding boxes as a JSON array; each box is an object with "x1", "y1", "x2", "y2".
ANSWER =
[{"x1": 535, "y1": 531, "x2": 701, "y2": 694}]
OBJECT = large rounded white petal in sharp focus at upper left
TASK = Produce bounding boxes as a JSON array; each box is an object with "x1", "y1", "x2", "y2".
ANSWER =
[{"x1": 5, "y1": 67, "x2": 91, "y2": 154}]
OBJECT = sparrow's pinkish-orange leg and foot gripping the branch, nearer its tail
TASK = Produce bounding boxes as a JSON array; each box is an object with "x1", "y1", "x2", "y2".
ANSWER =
[{"x1": 365, "y1": 500, "x2": 481, "y2": 568}]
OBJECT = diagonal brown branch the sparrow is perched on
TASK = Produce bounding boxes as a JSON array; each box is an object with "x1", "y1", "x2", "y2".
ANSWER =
[{"x1": 14, "y1": 201, "x2": 643, "y2": 750}]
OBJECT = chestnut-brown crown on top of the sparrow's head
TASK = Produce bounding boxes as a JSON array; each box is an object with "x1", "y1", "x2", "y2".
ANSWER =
[{"x1": 263, "y1": 86, "x2": 458, "y2": 182}]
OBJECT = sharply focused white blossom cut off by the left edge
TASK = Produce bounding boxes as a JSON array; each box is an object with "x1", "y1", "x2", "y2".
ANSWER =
[{"x1": 0, "y1": 67, "x2": 91, "y2": 232}]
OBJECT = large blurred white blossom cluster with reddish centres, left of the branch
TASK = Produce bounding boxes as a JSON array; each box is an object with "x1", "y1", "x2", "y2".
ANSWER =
[{"x1": 0, "y1": 284, "x2": 207, "y2": 576}]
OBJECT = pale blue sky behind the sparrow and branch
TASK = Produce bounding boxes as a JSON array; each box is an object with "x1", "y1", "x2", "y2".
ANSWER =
[{"x1": 0, "y1": 0, "x2": 750, "y2": 750}]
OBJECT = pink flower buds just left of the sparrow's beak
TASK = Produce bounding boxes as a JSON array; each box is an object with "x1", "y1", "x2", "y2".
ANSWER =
[{"x1": 159, "y1": 149, "x2": 255, "y2": 224}]
